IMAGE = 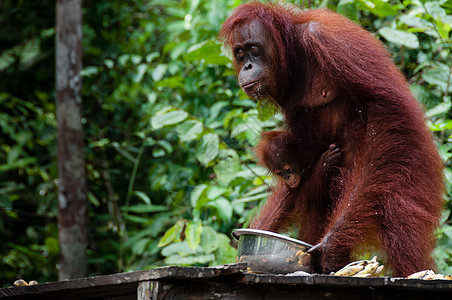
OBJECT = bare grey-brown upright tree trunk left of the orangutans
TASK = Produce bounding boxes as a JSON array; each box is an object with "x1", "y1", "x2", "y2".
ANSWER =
[{"x1": 56, "y1": 0, "x2": 87, "y2": 280}]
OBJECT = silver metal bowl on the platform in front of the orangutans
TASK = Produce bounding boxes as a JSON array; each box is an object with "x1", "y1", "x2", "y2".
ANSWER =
[{"x1": 232, "y1": 229, "x2": 313, "y2": 274}]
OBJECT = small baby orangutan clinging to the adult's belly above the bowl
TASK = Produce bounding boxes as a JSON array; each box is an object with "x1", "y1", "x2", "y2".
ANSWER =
[{"x1": 254, "y1": 131, "x2": 342, "y2": 243}]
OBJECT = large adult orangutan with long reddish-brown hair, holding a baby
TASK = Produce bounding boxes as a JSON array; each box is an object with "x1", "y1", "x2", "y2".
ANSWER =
[{"x1": 220, "y1": 2, "x2": 443, "y2": 276}]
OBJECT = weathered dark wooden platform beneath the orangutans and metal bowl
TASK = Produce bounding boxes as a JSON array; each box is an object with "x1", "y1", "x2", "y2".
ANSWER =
[{"x1": 0, "y1": 264, "x2": 452, "y2": 300}]
